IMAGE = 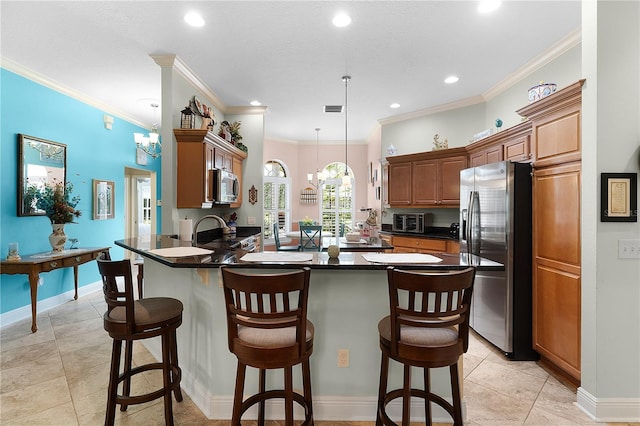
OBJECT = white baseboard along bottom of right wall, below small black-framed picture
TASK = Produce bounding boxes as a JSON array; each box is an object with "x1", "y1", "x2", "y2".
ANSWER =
[{"x1": 576, "y1": 387, "x2": 640, "y2": 423}]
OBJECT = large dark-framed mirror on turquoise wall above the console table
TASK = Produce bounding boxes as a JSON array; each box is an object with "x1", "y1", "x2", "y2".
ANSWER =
[{"x1": 18, "y1": 134, "x2": 67, "y2": 216}]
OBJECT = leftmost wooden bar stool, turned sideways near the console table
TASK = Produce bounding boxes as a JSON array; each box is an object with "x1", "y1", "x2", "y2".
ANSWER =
[{"x1": 97, "y1": 258, "x2": 183, "y2": 425}]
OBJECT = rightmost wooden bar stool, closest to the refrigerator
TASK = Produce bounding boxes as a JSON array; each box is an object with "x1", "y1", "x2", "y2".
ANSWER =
[{"x1": 376, "y1": 267, "x2": 475, "y2": 426}]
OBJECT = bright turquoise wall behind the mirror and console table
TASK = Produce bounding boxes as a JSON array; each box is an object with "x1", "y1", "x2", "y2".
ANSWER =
[{"x1": 0, "y1": 68, "x2": 161, "y2": 313}]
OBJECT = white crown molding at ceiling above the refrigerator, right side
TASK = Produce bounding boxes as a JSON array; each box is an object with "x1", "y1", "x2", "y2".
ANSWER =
[{"x1": 482, "y1": 27, "x2": 582, "y2": 101}]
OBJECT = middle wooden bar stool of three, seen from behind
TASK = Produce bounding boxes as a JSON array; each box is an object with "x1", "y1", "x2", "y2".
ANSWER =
[{"x1": 221, "y1": 266, "x2": 314, "y2": 426}]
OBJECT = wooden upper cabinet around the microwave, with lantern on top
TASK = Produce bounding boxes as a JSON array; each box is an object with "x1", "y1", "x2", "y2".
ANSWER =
[{"x1": 173, "y1": 129, "x2": 247, "y2": 209}]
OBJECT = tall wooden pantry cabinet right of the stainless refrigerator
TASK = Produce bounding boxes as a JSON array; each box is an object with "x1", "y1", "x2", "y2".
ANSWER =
[{"x1": 518, "y1": 80, "x2": 584, "y2": 384}]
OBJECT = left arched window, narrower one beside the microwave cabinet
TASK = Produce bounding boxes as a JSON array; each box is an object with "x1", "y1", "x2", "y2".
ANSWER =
[{"x1": 263, "y1": 160, "x2": 291, "y2": 239}]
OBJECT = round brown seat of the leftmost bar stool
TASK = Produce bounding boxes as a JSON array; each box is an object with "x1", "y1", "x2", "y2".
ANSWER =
[{"x1": 104, "y1": 297, "x2": 183, "y2": 331}]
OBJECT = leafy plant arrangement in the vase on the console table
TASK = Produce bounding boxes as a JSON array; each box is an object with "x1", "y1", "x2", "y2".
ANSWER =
[{"x1": 36, "y1": 180, "x2": 82, "y2": 223}]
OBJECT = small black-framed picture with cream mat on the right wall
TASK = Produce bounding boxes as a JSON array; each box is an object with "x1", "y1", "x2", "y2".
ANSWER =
[{"x1": 600, "y1": 173, "x2": 638, "y2": 222}]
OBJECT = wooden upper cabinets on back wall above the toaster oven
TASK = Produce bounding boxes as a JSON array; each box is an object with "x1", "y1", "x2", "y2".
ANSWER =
[{"x1": 387, "y1": 148, "x2": 468, "y2": 207}]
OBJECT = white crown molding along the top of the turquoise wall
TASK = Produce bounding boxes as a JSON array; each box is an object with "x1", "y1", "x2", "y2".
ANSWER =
[{"x1": 0, "y1": 56, "x2": 149, "y2": 129}]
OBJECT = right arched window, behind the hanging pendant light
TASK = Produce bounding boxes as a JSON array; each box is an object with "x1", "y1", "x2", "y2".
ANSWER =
[{"x1": 320, "y1": 163, "x2": 355, "y2": 236}]
